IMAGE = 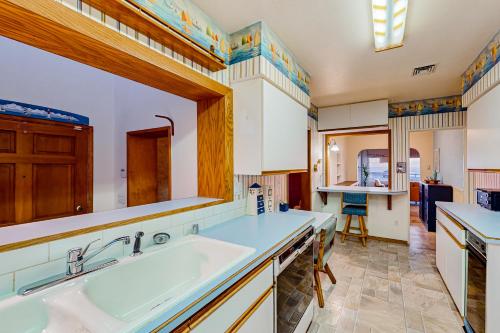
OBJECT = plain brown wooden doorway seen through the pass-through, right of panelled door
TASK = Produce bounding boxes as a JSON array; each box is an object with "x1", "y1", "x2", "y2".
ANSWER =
[{"x1": 127, "y1": 126, "x2": 172, "y2": 207}]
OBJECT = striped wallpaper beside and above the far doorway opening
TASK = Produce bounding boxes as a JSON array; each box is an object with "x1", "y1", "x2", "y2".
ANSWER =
[{"x1": 389, "y1": 111, "x2": 466, "y2": 191}]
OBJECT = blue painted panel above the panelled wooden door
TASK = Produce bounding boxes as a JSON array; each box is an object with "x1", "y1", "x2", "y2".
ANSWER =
[{"x1": 0, "y1": 99, "x2": 89, "y2": 125}]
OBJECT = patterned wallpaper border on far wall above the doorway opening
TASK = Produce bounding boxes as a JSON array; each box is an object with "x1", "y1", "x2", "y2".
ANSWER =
[{"x1": 389, "y1": 96, "x2": 467, "y2": 118}]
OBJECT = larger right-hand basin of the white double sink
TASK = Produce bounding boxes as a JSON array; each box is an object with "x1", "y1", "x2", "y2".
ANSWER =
[{"x1": 82, "y1": 235, "x2": 255, "y2": 322}]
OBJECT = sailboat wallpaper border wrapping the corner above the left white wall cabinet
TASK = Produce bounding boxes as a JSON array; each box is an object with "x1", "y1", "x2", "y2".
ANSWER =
[{"x1": 229, "y1": 22, "x2": 311, "y2": 95}]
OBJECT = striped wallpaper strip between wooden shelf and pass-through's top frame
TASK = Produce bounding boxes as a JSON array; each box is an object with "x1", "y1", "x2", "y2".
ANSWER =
[{"x1": 54, "y1": 0, "x2": 229, "y2": 85}]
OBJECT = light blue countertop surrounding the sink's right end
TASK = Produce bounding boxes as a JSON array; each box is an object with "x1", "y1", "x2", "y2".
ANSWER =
[{"x1": 139, "y1": 211, "x2": 315, "y2": 332}]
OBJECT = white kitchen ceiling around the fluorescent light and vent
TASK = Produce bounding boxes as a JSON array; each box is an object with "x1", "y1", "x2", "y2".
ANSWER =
[{"x1": 193, "y1": 0, "x2": 500, "y2": 106}]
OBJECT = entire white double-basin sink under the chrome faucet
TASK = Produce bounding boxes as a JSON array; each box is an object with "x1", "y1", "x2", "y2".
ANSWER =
[{"x1": 0, "y1": 235, "x2": 255, "y2": 333}]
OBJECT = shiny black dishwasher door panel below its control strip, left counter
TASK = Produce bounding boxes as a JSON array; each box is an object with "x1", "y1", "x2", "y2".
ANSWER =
[{"x1": 276, "y1": 243, "x2": 314, "y2": 333}]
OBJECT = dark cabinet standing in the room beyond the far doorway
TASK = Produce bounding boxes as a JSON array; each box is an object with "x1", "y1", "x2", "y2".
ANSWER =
[{"x1": 419, "y1": 183, "x2": 453, "y2": 231}]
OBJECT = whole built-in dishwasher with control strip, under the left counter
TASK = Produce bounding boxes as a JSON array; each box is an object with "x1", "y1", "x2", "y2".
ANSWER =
[{"x1": 274, "y1": 227, "x2": 314, "y2": 333}]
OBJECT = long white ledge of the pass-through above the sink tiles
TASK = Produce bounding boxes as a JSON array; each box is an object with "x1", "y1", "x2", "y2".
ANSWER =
[{"x1": 0, "y1": 197, "x2": 221, "y2": 246}]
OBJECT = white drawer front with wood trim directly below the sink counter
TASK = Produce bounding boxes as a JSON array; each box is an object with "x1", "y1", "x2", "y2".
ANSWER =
[{"x1": 189, "y1": 262, "x2": 273, "y2": 333}]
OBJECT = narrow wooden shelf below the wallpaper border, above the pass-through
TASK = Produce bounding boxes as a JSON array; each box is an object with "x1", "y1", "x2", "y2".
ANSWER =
[{"x1": 84, "y1": 0, "x2": 226, "y2": 71}]
